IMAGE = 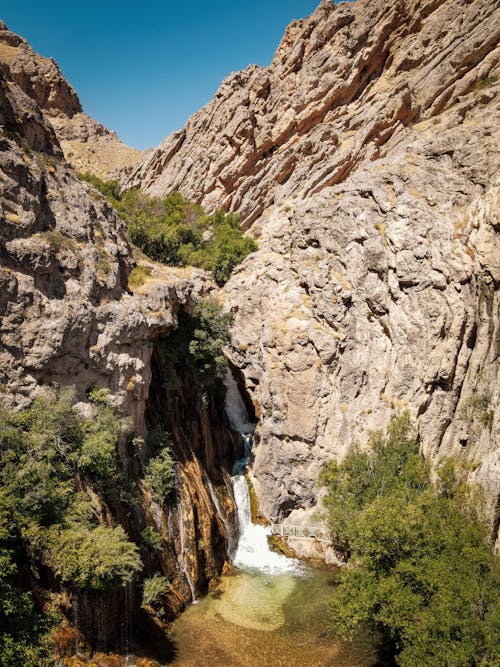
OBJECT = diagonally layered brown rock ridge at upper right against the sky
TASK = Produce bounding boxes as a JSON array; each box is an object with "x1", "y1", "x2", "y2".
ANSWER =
[{"x1": 124, "y1": 0, "x2": 500, "y2": 226}]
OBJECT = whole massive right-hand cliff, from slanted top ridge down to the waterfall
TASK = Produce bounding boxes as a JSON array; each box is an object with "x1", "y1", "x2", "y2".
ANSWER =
[{"x1": 123, "y1": 0, "x2": 500, "y2": 544}]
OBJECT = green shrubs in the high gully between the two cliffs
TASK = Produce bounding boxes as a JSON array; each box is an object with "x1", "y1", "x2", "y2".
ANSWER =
[{"x1": 81, "y1": 173, "x2": 257, "y2": 285}]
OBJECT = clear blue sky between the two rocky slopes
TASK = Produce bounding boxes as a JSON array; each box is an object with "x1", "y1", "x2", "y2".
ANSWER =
[{"x1": 0, "y1": 0, "x2": 336, "y2": 149}]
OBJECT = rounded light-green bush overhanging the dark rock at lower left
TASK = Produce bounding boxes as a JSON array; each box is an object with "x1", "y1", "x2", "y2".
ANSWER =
[{"x1": 50, "y1": 526, "x2": 142, "y2": 590}]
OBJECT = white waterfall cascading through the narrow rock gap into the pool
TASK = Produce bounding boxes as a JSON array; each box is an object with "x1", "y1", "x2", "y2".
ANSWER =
[{"x1": 225, "y1": 371, "x2": 300, "y2": 574}]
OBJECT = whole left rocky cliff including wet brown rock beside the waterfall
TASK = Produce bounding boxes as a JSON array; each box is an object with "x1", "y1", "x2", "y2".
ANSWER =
[{"x1": 0, "y1": 30, "x2": 238, "y2": 650}]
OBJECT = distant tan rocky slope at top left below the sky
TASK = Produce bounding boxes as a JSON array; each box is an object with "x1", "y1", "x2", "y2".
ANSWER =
[{"x1": 0, "y1": 23, "x2": 141, "y2": 178}]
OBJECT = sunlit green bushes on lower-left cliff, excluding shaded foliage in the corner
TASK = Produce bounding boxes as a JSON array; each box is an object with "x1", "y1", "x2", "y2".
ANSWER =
[{"x1": 0, "y1": 390, "x2": 143, "y2": 588}]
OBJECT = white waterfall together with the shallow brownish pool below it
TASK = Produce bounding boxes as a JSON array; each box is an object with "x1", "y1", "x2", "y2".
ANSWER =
[{"x1": 163, "y1": 376, "x2": 378, "y2": 667}]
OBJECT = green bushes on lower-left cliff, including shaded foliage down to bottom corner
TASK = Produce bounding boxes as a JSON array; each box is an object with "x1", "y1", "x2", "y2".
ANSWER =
[{"x1": 0, "y1": 392, "x2": 146, "y2": 667}]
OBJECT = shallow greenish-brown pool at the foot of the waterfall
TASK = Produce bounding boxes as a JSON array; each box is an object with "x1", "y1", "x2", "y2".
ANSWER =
[{"x1": 166, "y1": 568, "x2": 377, "y2": 667}]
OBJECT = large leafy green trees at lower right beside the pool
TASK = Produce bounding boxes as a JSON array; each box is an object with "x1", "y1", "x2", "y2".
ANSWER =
[{"x1": 322, "y1": 414, "x2": 500, "y2": 667}]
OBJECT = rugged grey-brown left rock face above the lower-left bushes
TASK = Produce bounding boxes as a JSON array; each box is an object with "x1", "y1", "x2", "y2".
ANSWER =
[{"x1": 0, "y1": 58, "x2": 213, "y2": 431}]
